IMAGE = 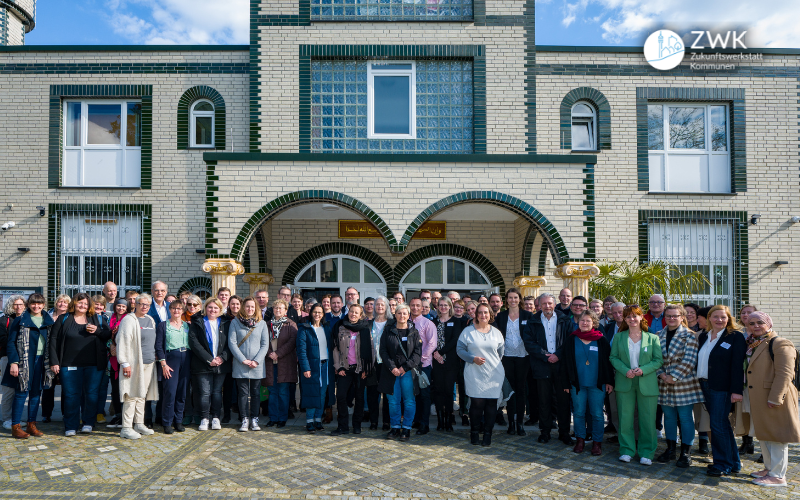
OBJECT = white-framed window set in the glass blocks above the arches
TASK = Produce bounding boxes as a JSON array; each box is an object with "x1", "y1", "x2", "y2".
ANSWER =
[{"x1": 367, "y1": 62, "x2": 417, "y2": 139}]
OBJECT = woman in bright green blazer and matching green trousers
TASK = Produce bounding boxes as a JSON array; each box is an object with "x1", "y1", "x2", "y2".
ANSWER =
[{"x1": 611, "y1": 305, "x2": 663, "y2": 465}]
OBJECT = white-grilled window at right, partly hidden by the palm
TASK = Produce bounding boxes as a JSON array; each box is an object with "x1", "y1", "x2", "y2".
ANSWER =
[{"x1": 647, "y1": 218, "x2": 738, "y2": 307}]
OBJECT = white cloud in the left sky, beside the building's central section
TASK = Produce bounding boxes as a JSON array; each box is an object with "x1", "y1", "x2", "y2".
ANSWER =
[{"x1": 106, "y1": 0, "x2": 250, "y2": 45}]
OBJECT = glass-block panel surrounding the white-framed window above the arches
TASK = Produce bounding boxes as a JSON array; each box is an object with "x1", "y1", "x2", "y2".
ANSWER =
[{"x1": 311, "y1": 60, "x2": 473, "y2": 153}]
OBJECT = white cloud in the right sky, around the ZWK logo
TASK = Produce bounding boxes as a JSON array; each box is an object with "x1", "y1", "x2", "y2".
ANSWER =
[{"x1": 562, "y1": 0, "x2": 800, "y2": 48}]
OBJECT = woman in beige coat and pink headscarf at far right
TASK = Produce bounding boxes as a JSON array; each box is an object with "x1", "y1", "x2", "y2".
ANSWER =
[{"x1": 746, "y1": 312, "x2": 800, "y2": 486}]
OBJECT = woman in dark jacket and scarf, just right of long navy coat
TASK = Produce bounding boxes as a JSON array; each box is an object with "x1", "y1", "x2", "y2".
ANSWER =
[{"x1": 331, "y1": 304, "x2": 375, "y2": 436}]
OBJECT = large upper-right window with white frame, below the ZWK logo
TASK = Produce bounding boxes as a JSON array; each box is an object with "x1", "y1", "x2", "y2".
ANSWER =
[{"x1": 647, "y1": 103, "x2": 731, "y2": 193}]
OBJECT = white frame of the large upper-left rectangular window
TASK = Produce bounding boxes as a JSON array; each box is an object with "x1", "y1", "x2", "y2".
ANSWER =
[{"x1": 61, "y1": 99, "x2": 142, "y2": 188}]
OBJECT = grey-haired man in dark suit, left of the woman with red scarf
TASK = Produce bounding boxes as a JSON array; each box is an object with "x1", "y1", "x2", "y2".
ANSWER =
[{"x1": 522, "y1": 293, "x2": 574, "y2": 446}]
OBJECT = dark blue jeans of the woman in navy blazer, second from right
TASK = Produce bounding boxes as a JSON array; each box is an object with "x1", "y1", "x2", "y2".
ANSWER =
[{"x1": 700, "y1": 380, "x2": 742, "y2": 472}]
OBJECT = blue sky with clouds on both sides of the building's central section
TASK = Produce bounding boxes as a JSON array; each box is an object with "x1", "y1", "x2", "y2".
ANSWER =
[{"x1": 26, "y1": 0, "x2": 800, "y2": 48}]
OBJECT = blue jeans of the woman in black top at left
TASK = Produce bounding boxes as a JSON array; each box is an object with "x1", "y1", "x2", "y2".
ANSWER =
[{"x1": 59, "y1": 366, "x2": 103, "y2": 431}]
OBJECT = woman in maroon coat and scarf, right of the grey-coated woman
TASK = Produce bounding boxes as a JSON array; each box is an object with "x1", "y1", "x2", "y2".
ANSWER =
[{"x1": 262, "y1": 299, "x2": 297, "y2": 428}]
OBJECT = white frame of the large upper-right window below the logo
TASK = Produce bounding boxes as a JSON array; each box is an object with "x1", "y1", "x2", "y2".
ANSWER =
[{"x1": 647, "y1": 101, "x2": 731, "y2": 193}]
